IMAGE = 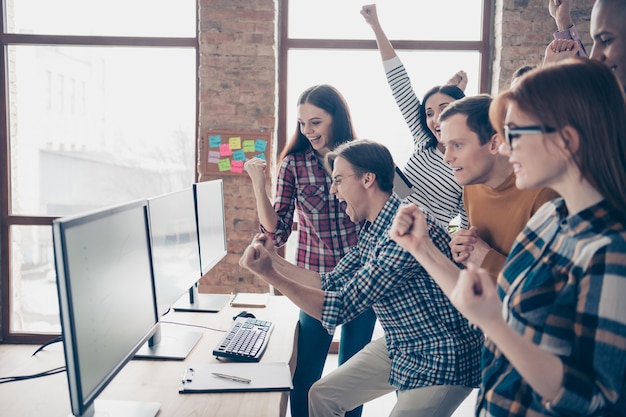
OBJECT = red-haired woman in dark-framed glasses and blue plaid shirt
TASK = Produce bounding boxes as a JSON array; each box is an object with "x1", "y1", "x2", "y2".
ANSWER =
[{"x1": 394, "y1": 58, "x2": 626, "y2": 417}]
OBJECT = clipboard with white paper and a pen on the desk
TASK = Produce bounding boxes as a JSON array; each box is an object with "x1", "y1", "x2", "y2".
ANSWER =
[{"x1": 178, "y1": 362, "x2": 293, "y2": 394}]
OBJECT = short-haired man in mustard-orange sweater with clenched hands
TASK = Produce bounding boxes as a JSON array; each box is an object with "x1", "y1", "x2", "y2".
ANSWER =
[{"x1": 439, "y1": 94, "x2": 558, "y2": 281}]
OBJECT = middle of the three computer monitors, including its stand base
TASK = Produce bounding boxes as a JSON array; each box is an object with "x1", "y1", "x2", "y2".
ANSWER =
[{"x1": 135, "y1": 187, "x2": 202, "y2": 360}]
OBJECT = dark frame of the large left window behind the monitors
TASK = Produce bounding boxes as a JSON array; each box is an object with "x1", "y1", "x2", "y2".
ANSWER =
[{"x1": 0, "y1": 0, "x2": 200, "y2": 343}]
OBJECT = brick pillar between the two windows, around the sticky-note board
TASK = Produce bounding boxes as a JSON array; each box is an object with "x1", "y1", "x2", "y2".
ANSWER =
[{"x1": 198, "y1": 0, "x2": 277, "y2": 293}]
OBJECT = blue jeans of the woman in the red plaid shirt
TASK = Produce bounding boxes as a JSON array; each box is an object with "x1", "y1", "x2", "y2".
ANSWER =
[{"x1": 290, "y1": 308, "x2": 376, "y2": 417}]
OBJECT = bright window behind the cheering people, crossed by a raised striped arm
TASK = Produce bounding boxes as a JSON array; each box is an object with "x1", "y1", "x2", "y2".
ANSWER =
[{"x1": 277, "y1": 0, "x2": 492, "y2": 166}]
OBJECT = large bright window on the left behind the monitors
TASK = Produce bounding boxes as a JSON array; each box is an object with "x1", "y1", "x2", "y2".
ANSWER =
[{"x1": 0, "y1": 0, "x2": 198, "y2": 342}]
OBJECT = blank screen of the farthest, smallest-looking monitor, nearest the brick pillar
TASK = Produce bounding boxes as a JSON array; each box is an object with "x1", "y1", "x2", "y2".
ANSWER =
[{"x1": 193, "y1": 180, "x2": 226, "y2": 275}]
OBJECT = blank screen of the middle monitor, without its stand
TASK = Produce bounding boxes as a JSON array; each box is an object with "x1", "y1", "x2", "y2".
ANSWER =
[{"x1": 148, "y1": 187, "x2": 201, "y2": 315}]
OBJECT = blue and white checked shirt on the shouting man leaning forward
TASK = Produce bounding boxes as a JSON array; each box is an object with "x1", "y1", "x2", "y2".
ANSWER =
[{"x1": 321, "y1": 194, "x2": 483, "y2": 390}]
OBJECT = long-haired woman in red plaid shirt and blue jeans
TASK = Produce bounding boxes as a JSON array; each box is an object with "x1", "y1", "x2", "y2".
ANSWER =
[{"x1": 244, "y1": 85, "x2": 376, "y2": 417}]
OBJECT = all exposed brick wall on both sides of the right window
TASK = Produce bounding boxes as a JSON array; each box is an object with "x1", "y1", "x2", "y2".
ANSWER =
[{"x1": 198, "y1": 0, "x2": 593, "y2": 292}]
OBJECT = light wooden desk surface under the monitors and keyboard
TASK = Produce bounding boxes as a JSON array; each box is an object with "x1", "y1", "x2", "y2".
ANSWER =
[{"x1": 0, "y1": 296, "x2": 298, "y2": 417}]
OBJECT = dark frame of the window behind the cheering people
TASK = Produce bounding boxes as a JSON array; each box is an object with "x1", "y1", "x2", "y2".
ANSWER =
[{"x1": 276, "y1": 0, "x2": 493, "y2": 152}]
